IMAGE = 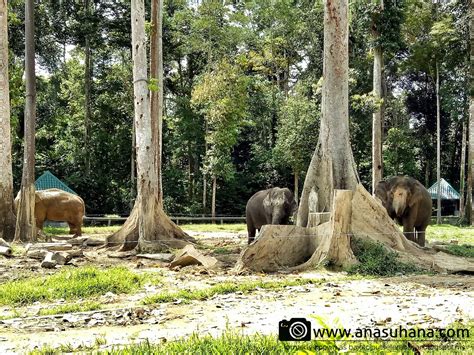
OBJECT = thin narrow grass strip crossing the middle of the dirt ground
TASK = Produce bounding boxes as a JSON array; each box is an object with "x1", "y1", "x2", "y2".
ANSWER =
[{"x1": 142, "y1": 279, "x2": 319, "y2": 305}]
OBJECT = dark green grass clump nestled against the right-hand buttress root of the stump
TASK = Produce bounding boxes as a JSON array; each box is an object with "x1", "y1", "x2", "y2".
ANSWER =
[{"x1": 347, "y1": 238, "x2": 423, "y2": 276}]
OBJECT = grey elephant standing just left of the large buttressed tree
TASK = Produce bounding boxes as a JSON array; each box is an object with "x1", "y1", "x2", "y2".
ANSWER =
[{"x1": 245, "y1": 187, "x2": 297, "y2": 244}]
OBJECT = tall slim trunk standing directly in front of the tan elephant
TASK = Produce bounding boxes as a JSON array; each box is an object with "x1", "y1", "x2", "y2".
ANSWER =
[{"x1": 14, "y1": 0, "x2": 36, "y2": 242}]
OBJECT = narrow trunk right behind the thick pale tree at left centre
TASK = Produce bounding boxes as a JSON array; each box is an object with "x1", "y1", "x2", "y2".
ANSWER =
[{"x1": 150, "y1": 0, "x2": 164, "y2": 203}]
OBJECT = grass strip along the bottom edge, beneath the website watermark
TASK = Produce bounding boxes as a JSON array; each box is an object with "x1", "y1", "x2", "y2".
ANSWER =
[{"x1": 30, "y1": 322, "x2": 474, "y2": 355}]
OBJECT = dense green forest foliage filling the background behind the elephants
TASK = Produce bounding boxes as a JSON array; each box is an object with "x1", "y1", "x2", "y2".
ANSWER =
[{"x1": 8, "y1": 0, "x2": 469, "y2": 215}]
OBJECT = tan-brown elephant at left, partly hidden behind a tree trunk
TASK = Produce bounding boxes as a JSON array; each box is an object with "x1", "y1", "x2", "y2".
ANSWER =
[{"x1": 15, "y1": 189, "x2": 85, "y2": 237}]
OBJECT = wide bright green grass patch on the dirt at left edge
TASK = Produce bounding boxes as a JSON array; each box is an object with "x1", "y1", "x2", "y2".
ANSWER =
[{"x1": 0, "y1": 267, "x2": 159, "y2": 305}]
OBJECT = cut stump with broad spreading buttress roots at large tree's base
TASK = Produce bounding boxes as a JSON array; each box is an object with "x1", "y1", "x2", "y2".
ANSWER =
[{"x1": 234, "y1": 184, "x2": 474, "y2": 273}]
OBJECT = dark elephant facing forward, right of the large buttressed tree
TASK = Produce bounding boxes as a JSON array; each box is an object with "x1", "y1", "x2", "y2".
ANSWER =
[{"x1": 374, "y1": 176, "x2": 432, "y2": 247}]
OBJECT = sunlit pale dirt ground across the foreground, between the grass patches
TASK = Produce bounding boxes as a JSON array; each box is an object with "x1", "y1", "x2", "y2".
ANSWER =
[{"x1": 0, "y1": 232, "x2": 474, "y2": 354}]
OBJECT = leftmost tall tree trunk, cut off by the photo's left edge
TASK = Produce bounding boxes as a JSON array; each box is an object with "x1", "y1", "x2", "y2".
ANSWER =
[{"x1": 0, "y1": 0, "x2": 15, "y2": 241}]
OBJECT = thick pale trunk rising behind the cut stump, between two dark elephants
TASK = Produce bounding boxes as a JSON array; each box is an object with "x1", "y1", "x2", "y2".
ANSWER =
[{"x1": 297, "y1": 0, "x2": 358, "y2": 227}]
